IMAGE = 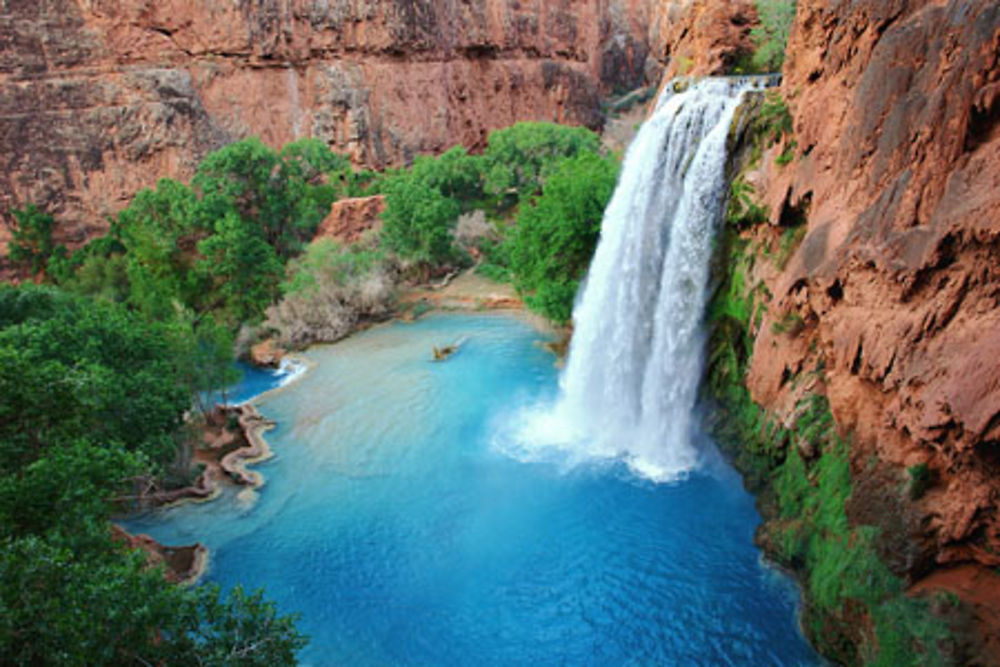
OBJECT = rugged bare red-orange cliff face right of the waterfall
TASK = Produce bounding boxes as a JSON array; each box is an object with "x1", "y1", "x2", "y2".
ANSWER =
[{"x1": 748, "y1": 0, "x2": 1000, "y2": 596}]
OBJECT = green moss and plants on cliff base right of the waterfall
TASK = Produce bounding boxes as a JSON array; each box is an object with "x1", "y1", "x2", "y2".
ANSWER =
[{"x1": 704, "y1": 168, "x2": 950, "y2": 665}]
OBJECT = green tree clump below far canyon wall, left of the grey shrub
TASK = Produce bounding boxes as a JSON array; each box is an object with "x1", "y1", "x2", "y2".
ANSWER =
[{"x1": 50, "y1": 139, "x2": 344, "y2": 330}]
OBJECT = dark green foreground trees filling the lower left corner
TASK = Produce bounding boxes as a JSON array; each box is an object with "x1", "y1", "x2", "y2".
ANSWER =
[{"x1": 0, "y1": 286, "x2": 303, "y2": 665}]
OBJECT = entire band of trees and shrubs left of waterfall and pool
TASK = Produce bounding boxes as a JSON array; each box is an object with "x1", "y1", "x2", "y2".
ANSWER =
[{"x1": 0, "y1": 123, "x2": 618, "y2": 665}]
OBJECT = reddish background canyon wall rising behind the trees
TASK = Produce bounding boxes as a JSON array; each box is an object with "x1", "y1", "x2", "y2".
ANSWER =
[{"x1": 0, "y1": 0, "x2": 663, "y2": 252}]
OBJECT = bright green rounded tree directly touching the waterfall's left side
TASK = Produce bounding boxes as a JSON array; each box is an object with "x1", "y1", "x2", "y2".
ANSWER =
[{"x1": 506, "y1": 153, "x2": 618, "y2": 322}]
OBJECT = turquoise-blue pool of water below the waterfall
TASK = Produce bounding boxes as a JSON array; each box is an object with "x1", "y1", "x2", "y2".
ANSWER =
[{"x1": 127, "y1": 315, "x2": 817, "y2": 666}]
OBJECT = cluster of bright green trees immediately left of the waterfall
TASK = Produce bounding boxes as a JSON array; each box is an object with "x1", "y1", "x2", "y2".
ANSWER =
[{"x1": 382, "y1": 123, "x2": 618, "y2": 322}]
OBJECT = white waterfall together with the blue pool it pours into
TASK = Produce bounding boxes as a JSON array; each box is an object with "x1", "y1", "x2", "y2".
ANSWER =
[{"x1": 126, "y1": 80, "x2": 817, "y2": 665}]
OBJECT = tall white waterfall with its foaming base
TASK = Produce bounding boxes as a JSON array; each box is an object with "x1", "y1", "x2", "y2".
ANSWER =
[{"x1": 504, "y1": 78, "x2": 762, "y2": 481}]
